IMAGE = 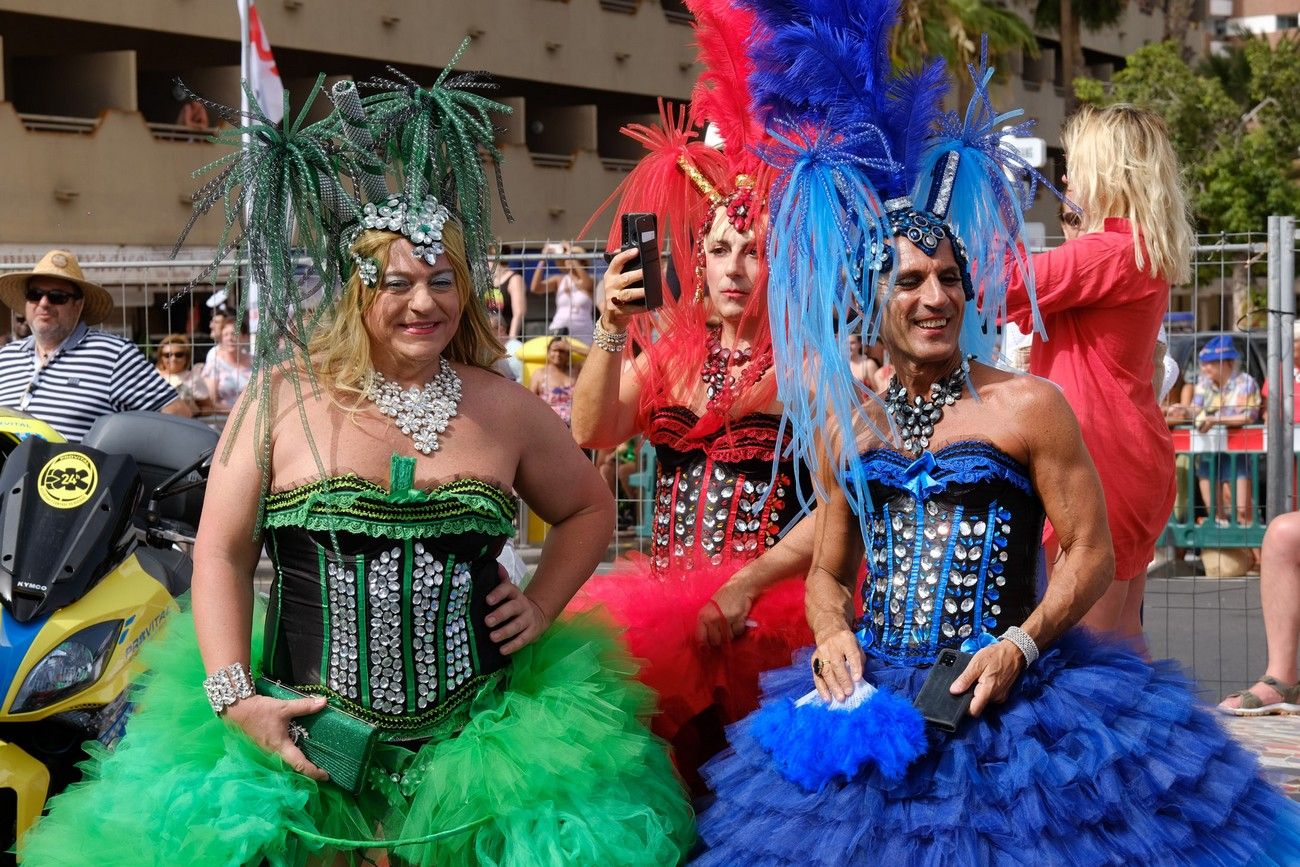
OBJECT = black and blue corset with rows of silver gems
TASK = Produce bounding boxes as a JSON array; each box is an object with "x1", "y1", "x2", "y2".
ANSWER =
[{"x1": 858, "y1": 442, "x2": 1043, "y2": 664}]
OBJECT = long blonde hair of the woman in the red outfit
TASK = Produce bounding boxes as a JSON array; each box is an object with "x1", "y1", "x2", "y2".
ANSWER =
[{"x1": 1061, "y1": 103, "x2": 1195, "y2": 283}]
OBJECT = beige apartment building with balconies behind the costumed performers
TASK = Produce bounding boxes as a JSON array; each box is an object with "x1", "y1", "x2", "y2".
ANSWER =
[{"x1": 0, "y1": 0, "x2": 1196, "y2": 333}]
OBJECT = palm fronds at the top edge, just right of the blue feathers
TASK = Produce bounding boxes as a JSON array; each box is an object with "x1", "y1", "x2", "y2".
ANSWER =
[{"x1": 893, "y1": 0, "x2": 1039, "y2": 104}]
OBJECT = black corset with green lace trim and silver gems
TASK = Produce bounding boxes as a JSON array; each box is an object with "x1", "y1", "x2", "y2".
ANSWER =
[{"x1": 264, "y1": 456, "x2": 515, "y2": 740}]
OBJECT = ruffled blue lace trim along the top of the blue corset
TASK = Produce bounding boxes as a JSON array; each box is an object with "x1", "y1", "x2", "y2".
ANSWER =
[{"x1": 859, "y1": 439, "x2": 1034, "y2": 495}]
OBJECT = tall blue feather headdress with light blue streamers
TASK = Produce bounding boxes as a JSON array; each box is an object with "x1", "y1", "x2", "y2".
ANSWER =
[{"x1": 740, "y1": 0, "x2": 1045, "y2": 515}]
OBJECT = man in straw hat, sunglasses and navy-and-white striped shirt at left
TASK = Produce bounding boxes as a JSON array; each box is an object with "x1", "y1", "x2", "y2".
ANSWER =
[{"x1": 0, "y1": 250, "x2": 190, "y2": 442}]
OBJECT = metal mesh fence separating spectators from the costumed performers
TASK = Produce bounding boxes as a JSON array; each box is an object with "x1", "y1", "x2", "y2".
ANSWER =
[{"x1": 0, "y1": 217, "x2": 1300, "y2": 698}]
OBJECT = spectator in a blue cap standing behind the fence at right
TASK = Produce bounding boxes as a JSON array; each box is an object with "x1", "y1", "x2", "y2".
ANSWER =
[{"x1": 1188, "y1": 334, "x2": 1260, "y2": 525}]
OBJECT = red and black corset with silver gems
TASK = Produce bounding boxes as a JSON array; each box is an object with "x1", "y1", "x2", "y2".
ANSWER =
[{"x1": 647, "y1": 407, "x2": 801, "y2": 572}]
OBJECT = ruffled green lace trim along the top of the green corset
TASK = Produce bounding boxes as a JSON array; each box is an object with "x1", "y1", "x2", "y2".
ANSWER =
[{"x1": 263, "y1": 455, "x2": 515, "y2": 539}]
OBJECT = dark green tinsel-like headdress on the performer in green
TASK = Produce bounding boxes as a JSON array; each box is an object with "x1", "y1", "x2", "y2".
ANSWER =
[{"x1": 172, "y1": 39, "x2": 511, "y2": 501}]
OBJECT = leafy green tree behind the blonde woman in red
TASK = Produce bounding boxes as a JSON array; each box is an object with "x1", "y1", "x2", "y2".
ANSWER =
[{"x1": 1075, "y1": 39, "x2": 1300, "y2": 233}]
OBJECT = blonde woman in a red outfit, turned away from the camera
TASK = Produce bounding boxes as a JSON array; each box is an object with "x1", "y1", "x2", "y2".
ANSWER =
[{"x1": 1006, "y1": 104, "x2": 1192, "y2": 647}]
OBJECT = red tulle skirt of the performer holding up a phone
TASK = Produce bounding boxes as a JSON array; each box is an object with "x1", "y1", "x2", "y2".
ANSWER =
[{"x1": 569, "y1": 554, "x2": 813, "y2": 780}]
